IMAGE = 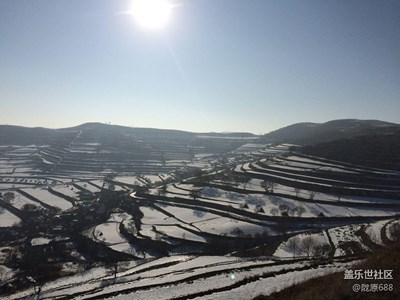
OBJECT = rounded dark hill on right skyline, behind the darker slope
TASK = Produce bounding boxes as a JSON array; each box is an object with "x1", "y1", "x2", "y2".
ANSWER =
[{"x1": 260, "y1": 119, "x2": 400, "y2": 145}]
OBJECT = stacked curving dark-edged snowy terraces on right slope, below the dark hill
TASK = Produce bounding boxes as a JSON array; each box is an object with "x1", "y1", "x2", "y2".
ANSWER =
[{"x1": 234, "y1": 156, "x2": 400, "y2": 209}]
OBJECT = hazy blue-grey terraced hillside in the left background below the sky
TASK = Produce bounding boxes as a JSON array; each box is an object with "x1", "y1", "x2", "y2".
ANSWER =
[{"x1": 0, "y1": 123, "x2": 259, "y2": 174}]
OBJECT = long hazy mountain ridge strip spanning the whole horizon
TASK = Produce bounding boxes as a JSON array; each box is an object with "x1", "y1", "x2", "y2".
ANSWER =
[{"x1": 0, "y1": 119, "x2": 400, "y2": 145}]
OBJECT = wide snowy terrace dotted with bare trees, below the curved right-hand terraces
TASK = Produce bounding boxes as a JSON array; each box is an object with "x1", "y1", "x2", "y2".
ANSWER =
[{"x1": 162, "y1": 180, "x2": 400, "y2": 218}]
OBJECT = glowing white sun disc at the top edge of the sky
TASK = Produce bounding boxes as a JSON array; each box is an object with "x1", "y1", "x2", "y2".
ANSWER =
[{"x1": 132, "y1": 0, "x2": 172, "y2": 29}]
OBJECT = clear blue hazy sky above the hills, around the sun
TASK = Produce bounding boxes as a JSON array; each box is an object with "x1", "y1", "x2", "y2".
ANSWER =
[{"x1": 0, "y1": 0, "x2": 400, "y2": 134}]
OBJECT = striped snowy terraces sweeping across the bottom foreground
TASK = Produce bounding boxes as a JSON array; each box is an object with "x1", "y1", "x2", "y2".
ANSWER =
[{"x1": 5, "y1": 256, "x2": 354, "y2": 300}]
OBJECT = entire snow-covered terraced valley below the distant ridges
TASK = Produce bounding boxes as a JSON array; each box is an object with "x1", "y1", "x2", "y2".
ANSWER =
[{"x1": 0, "y1": 139, "x2": 400, "y2": 300}]
